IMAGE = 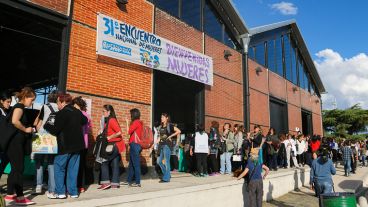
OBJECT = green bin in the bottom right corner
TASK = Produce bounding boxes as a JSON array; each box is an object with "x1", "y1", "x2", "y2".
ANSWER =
[{"x1": 320, "y1": 192, "x2": 356, "y2": 207}]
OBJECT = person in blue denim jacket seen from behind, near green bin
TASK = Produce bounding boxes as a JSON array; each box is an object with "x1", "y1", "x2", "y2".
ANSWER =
[{"x1": 310, "y1": 147, "x2": 336, "y2": 197}]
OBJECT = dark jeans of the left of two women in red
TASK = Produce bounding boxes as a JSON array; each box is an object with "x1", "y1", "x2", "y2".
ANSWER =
[{"x1": 101, "y1": 146, "x2": 120, "y2": 186}]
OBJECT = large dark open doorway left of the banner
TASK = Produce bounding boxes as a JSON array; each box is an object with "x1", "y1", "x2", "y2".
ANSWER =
[{"x1": 0, "y1": 2, "x2": 65, "y2": 108}]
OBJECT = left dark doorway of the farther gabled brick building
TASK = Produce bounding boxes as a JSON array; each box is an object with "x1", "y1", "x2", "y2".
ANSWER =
[{"x1": 270, "y1": 98, "x2": 289, "y2": 133}]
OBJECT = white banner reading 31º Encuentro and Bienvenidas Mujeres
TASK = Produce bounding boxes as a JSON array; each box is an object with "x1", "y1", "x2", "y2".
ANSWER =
[{"x1": 96, "y1": 13, "x2": 213, "y2": 86}]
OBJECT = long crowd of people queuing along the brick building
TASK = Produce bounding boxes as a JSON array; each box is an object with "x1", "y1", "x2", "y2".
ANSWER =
[{"x1": 0, "y1": 87, "x2": 367, "y2": 206}]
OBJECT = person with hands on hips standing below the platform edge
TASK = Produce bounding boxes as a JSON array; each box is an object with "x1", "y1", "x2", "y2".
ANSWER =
[{"x1": 237, "y1": 153, "x2": 269, "y2": 207}]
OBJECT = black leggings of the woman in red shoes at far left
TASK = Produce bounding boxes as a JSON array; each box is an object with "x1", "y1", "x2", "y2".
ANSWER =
[{"x1": 7, "y1": 132, "x2": 26, "y2": 197}]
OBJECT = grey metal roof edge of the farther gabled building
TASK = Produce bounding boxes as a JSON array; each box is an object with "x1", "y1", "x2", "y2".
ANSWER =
[{"x1": 249, "y1": 20, "x2": 326, "y2": 93}]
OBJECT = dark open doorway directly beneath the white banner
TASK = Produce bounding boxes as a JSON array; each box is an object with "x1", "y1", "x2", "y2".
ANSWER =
[{"x1": 153, "y1": 70, "x2": 204, "y2": 134}]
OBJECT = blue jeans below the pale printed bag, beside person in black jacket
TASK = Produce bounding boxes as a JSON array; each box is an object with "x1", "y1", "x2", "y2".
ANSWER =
[{"x1": 35, "y1": 154, "x2": 55, "y2": 193}]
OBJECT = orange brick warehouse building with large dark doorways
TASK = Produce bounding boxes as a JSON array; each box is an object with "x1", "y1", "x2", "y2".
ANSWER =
[{"x1": 0, "y1": 0, "x2": 324, "y2": 167}]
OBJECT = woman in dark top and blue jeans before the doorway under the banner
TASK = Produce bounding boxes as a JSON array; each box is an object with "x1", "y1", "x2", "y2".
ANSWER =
[{"x1": 158, "y1": 113, "x2": 181, "y2": 183}]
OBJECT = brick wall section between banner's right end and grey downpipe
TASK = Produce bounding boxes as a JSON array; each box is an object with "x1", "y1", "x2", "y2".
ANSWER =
[{"x1": 205, "y1": 35, "x2": 244, "y2": 128}]
